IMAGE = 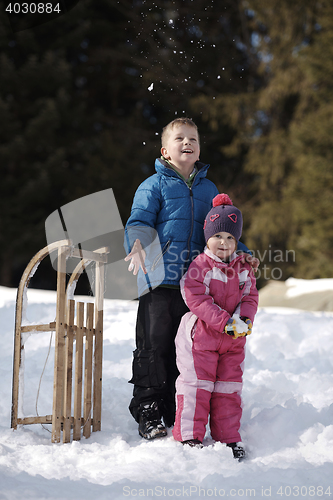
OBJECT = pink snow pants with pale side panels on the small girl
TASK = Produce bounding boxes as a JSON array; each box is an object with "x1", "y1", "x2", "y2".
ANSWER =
[{"x1": 172, "y1": 312, "x2": 246, "y2": 443}]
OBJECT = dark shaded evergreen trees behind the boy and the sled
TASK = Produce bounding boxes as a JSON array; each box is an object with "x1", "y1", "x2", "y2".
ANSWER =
[{"x1": 0, "y1": 0, "x2": 258, "y2": 286}]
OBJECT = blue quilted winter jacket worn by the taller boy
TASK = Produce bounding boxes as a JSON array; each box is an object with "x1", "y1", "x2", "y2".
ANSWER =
[{"x1": 125, "y1": 159, "x2": 246, "y2": 295}]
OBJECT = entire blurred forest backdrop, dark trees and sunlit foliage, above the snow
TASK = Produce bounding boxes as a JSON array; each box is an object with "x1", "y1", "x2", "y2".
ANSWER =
[{"x1": 0, "y1": 0, "x2": 333, "y2": 287}]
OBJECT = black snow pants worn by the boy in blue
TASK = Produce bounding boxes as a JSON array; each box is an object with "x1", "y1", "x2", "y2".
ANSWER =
[{"x1": 129, "y1": 287, "x2": 188, "y2": 427}]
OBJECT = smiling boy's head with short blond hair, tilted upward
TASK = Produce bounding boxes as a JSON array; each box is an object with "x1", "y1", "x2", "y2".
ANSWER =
[{"x1": 161, "y1": 125, "x2": 200, "y2": 173}]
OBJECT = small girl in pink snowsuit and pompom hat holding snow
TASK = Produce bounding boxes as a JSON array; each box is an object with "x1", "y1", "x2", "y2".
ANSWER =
[{"x1": 173, "y1": 194, "x2": 258, "y2": 459}]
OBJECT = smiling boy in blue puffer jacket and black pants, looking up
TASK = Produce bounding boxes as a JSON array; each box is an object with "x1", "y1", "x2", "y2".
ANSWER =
[{"x1": 125, "y1": 118, "x2": 258, "y2": 439}]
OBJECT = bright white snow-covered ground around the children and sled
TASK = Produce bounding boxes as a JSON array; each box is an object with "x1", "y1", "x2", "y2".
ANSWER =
[{"x1": 0, "y1": 282, "x2": 333, "y2": 500}]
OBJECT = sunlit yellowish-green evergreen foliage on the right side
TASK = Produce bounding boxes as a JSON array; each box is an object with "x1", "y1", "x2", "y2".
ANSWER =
[{"x1": 189, "y1": 0, "x2": 333, "y2": 284}]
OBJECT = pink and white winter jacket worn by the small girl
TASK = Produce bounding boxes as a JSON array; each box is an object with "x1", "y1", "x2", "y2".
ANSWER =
[{"x1": 180, "y1": 247, "x2": 258, "y2": 340}]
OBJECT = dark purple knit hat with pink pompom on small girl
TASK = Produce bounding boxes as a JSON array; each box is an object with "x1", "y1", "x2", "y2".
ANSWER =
[{"x1": 204, "y1": 193, "x2": 243, "y2": 242}]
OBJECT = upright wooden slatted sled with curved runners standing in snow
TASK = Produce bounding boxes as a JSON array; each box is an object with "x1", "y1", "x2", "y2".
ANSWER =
[{"x1": 11, "y1": 240, "x2": 108, "y2": 443}]
